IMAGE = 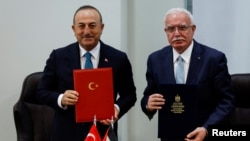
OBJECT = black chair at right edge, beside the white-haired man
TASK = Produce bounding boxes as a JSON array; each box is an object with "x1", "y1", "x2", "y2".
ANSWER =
[{"x1": 229, "y1": 73, "x2": 250, "y2": 125}]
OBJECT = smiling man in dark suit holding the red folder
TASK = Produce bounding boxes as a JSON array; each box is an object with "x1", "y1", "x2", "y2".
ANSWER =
[{"x1": 37, "y1": 5, "x2": 137, "y2": 141}]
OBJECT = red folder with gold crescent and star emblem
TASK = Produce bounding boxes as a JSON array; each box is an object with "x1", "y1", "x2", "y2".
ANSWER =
[{"x1": 74, "y1": 68, "x2": 114, "y2": 122}]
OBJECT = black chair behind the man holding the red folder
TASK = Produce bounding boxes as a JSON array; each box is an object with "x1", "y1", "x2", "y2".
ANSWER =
[{"x1": 13, "y1": 72, "x2": 54, "y2": 141}]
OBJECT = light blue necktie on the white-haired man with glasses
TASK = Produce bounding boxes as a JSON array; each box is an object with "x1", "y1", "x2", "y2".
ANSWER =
[{"x1": 175, "y1": 56, "x2": 184, "y2": 84}]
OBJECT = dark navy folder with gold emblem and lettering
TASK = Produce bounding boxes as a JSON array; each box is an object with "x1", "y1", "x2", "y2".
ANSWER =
[{"x1": 158, "y1": 84, "x2": 198, "y2": 139}]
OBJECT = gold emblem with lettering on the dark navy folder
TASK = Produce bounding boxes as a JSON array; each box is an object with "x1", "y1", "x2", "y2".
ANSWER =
[{"x1": 171, "y1": 94, "x2": 185, "y2": 114}]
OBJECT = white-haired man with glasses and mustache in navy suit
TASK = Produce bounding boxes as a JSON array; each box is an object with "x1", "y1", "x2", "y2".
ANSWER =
[{"x1": 141, "y1": 8, "x2": 234, "y2": 141}]
